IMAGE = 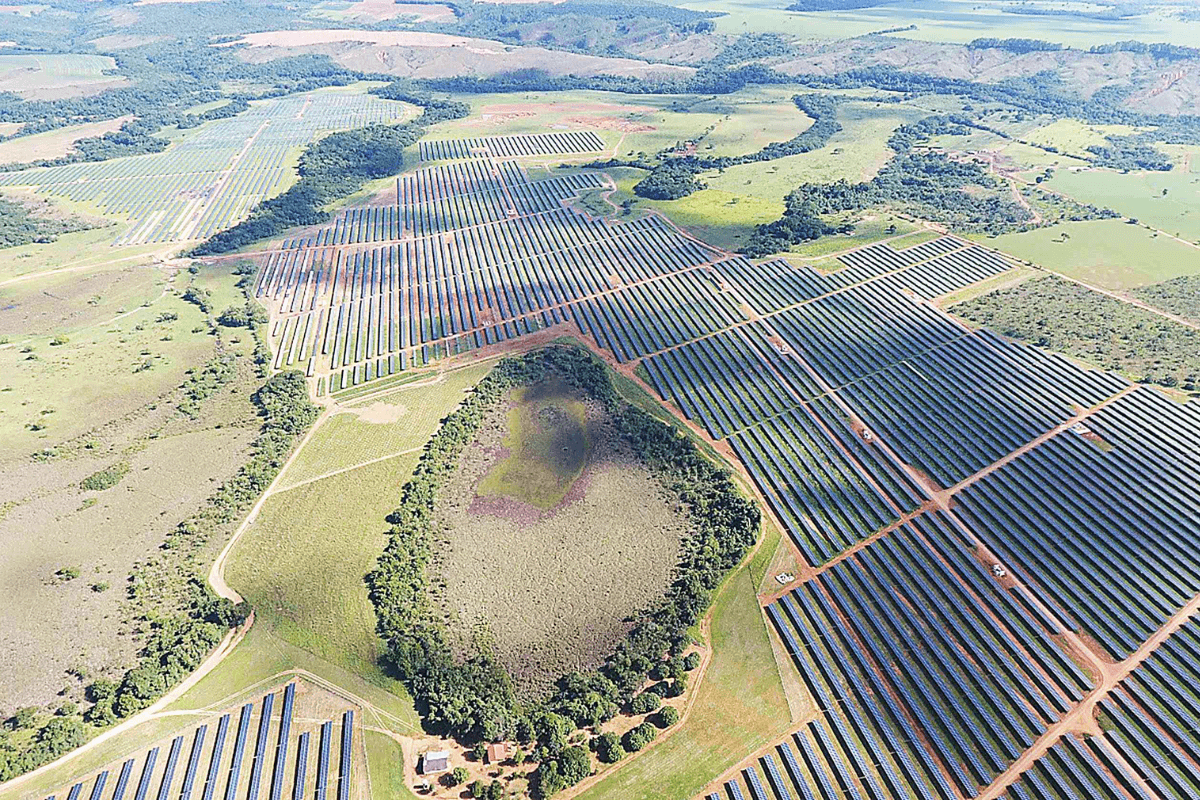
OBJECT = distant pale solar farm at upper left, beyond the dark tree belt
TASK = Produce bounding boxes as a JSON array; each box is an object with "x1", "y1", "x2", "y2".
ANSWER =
[{"x1": 0, "y1": 91, "x2": 408, "y2": 245}]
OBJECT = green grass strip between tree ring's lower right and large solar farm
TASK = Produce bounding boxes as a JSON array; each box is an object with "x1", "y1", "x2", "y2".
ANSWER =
[{"x1": 580, "y1": 566, "x2": 792, "y2": 800}]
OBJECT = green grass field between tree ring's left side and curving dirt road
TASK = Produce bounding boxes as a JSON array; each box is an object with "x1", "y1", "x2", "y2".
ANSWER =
[{"x1": 226, "y1": 365, "x2": 506, "y2": 692}]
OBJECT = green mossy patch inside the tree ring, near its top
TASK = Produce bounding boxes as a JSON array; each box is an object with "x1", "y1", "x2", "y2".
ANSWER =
[{"x1": 476, "y1": 380, "x2": 593, "y2": 511}]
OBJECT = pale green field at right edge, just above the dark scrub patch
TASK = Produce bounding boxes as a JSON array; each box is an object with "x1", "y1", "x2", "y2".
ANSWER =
[{"x1": 983, "y1": 219, "x2": 1200, "y2": 290}]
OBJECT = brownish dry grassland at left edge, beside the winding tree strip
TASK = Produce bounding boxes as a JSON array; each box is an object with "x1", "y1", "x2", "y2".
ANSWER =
[{"x1": 0, "y1": 403, "x2": 253, "y2": 714}]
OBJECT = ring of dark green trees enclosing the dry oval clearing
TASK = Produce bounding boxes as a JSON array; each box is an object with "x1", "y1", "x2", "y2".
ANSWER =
[{"x1": 366, "y1": 345, "x2": 760, "y2": 796}]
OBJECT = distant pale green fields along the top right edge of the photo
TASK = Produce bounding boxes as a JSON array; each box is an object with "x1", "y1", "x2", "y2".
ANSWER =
[{"x1": 685, "y1": 0, "x2": 1200, "y2": 47}]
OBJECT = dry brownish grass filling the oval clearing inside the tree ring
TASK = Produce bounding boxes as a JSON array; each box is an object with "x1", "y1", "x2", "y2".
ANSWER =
[{"x1": 438, "y1": 387, "x2": 686, "y2": 697}]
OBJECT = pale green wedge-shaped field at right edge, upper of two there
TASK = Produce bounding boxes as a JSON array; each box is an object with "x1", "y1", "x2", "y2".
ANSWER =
[{"x1": 1049, "y1": 169, "x2": 1200, "y2": 241}]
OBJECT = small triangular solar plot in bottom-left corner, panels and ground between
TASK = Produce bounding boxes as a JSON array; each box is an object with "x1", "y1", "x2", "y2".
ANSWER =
[{"x1": 39, "y1": 681, "x2": 370, "y2": 800}]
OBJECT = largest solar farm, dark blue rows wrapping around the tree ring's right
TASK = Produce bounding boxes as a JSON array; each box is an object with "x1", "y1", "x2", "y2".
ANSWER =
[{"x1": 243, "y1": 131, "x2": 1200, "y2": 800}]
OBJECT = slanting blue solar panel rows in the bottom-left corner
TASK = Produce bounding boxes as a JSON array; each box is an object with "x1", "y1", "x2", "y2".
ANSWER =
[{"x1": 48, "y1": 682, "x2": 355, "y2": 800}]
